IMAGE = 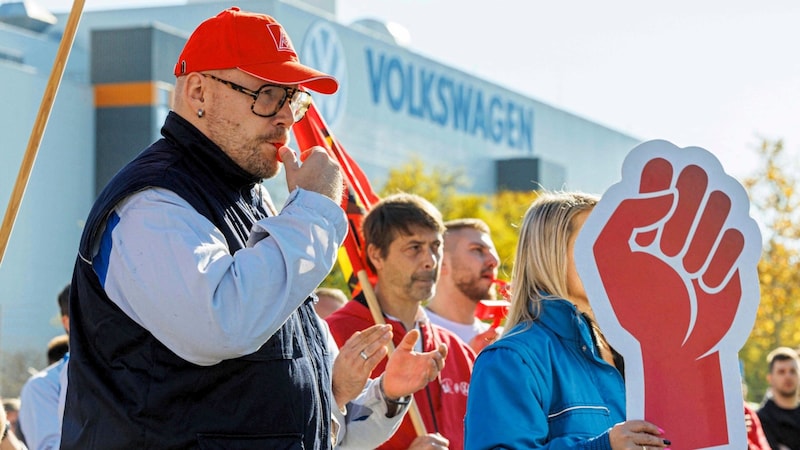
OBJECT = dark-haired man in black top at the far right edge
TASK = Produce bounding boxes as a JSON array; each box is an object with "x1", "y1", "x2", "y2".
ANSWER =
[{"x1": 758, "y1": 347, "x2": 800, "y2": 450}]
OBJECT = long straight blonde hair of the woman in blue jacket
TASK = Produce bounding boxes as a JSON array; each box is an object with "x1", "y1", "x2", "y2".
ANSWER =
[{"x1": 505, "y1": 191, "x2": 599, "y2": 330}]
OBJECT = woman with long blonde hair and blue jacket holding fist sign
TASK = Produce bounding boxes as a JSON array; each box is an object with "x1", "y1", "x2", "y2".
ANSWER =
[{"x1": 465, "y1": 192, "x2": 670, "y2": 450}]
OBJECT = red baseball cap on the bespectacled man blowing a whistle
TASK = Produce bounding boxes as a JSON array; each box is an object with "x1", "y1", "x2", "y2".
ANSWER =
[{"x1": 175, "y1": 7, "x2": 339, "y2": 94}]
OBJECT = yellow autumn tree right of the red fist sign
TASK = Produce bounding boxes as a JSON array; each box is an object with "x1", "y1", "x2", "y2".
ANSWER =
[{"x1": 739, "y1": 141, "x2": 800, "y2": 401}]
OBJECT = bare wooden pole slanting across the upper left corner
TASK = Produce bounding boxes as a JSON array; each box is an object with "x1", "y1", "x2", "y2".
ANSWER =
[{"x1": 0, "y1": 0, "x2": 85, "y2": 264}]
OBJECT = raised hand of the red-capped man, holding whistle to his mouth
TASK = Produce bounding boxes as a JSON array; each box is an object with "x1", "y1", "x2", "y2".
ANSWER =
[{"x1": 278, "y1": 146, "x2": 344, "y2": 204}]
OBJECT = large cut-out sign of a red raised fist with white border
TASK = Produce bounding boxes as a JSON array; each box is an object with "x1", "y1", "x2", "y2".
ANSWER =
[{"x1": 575, "y1": 141, "x2": 761, "y2": 450}]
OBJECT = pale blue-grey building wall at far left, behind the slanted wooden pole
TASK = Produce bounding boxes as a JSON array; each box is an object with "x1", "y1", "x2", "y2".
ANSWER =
[{"x1": 0, "y1": 64, "x2": 94, "y2": 355}]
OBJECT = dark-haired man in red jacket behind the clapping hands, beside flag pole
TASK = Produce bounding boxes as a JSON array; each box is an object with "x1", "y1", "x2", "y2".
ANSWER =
[{"x1": 326, "y1": 193, "x2": 475, "y2": 449}]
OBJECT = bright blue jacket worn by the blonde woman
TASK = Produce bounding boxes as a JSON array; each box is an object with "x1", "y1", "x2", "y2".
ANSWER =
[{"x1": 464, "y1": 299, "x2": 625, "y2": 450}]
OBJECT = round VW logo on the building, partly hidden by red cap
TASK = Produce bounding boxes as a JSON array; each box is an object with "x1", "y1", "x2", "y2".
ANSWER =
[{"x1": 300, "y1": 21, "x2": 347, "y2": 127}]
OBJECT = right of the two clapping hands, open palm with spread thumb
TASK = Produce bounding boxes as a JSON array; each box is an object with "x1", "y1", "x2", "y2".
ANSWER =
[{"x1": 383, "y1": 330, "x2": 447, "y2": 400}]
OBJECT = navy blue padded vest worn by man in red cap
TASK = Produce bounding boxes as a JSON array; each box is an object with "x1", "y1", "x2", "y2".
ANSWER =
[{"x1": 61, "y1": 113, "x2": 332, "y2": 450}]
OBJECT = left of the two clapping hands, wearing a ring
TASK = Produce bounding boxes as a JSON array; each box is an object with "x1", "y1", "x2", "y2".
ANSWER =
[{"x1": 331, "y1": 325, "x2": 392, "y2": 409}]
